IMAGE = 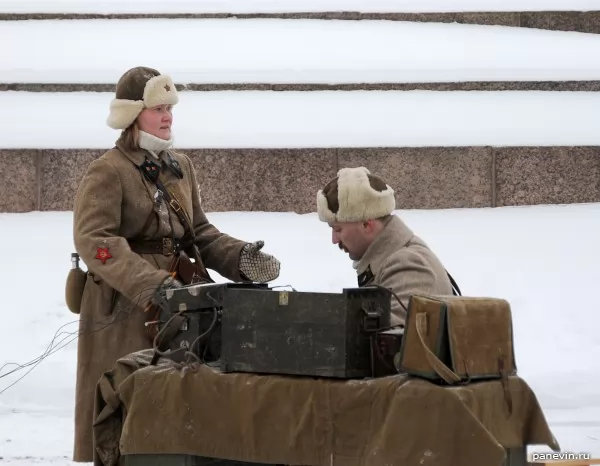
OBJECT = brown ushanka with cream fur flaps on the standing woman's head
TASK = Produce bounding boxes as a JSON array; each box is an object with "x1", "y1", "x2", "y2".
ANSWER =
[{"x1": 106, "y1": 66, "x2": 179, "y2": 129}]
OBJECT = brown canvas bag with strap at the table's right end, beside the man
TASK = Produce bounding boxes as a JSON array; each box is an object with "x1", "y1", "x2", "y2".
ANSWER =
[{"x1": 397, "y1": 295, "x2": 517, "y2": 385}]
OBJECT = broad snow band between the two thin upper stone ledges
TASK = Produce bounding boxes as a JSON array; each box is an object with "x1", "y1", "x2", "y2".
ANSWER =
[{"x1": 0, "y1": 18, "x2": 600, "y2": 84}]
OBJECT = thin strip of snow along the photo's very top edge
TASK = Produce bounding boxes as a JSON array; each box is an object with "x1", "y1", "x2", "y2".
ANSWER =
[{"x1": 0, "y1": 0, "x2": 599, "y2": 14}]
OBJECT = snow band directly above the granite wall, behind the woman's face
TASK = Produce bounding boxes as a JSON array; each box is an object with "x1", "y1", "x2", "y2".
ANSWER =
[{"x1": 0, "y1": 91, "x2": 600, "y2": 149}]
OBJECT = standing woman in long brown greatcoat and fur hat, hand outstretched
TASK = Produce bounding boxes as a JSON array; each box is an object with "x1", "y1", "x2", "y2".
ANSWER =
[{"x1": 67, "y1": 67, "x2": 279, "y2": 462}]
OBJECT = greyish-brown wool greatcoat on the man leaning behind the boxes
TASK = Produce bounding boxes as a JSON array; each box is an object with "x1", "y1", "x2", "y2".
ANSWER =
[{"x1": 356, "y1": 215, "x2": 452, "y2": 326}]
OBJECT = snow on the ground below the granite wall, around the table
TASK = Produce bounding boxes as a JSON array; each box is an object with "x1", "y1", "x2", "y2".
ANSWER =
[{"x1": 0, "y1": 204, "x2": 600, "y2": 466}]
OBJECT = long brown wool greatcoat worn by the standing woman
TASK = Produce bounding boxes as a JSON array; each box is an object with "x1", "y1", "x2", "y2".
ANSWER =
[{"x1": 73, "y1": 139, "x2": 247, "y2": 462}]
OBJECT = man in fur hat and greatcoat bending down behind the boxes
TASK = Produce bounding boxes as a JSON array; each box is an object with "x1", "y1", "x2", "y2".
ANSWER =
[{"x1": 317, "y1": 167, "x2": 453, "y2": 326}]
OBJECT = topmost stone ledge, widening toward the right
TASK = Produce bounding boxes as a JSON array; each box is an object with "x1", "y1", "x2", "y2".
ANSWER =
[{"x1": 0, "y1": 11, "x2": 600, "y2": 33}]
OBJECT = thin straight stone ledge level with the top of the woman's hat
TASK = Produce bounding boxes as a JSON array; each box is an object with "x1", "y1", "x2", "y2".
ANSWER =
[{"x1": 0, "y1": 80, "x2": 600, "y2": 92}]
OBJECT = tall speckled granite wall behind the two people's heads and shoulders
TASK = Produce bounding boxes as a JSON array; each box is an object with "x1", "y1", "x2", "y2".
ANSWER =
[{"x1": 0, "y1": 146, "x2": 600, "y2": 213}]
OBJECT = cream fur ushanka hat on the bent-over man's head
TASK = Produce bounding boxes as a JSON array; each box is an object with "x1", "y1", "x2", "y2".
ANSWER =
[{"x1": 317, "y1": 167, "x2": 396, "y2": 223}]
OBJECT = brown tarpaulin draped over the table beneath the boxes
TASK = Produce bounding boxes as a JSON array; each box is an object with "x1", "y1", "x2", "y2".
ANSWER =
[{"x1": 94, "y1": 350, "x2": 559, "y2": 466}]
